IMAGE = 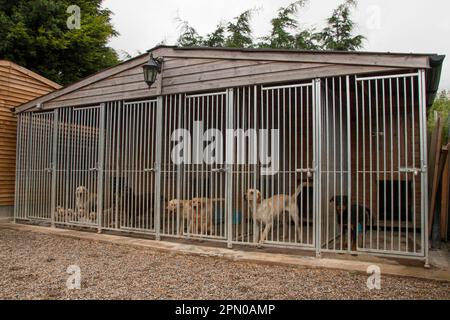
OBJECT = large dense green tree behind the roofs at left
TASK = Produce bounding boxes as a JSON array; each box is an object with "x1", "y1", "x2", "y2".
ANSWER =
[{"x1": 0, "y1": 0, "x2": 118, "y2": 84}]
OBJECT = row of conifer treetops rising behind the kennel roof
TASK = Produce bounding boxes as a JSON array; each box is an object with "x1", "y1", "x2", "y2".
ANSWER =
[{"x1": 177, "y1": 0, "x2": 364, "y2": 50}]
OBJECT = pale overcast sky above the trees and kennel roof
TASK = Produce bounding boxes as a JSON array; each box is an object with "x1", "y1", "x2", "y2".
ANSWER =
[{"x1": 103, "y1": 0, "x2": 450, "y2": 89}]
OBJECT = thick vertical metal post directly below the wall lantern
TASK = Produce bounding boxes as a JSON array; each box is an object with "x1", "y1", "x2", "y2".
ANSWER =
[{"x1": 154, "y1": 96, "x2": 163, "y2": 240}]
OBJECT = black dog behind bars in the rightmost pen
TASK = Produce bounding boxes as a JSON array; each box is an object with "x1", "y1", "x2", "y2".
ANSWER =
[{"x1": 330, "y1": 196, "x2": 370, "y2": 251}]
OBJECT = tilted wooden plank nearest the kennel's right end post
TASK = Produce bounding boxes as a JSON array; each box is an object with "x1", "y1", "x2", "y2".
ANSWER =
[{"x1": 428, "y1": 116, "x2": 442, "y2": 236}]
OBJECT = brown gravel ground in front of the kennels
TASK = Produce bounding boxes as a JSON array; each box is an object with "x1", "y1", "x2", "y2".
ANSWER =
[{"x1": 0, "y1": 229, "x2": 450, "y2": 299}]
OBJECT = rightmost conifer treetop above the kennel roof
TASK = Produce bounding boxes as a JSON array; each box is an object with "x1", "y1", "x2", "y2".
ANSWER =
[{"x1": 320, "y1": 0, "x2": 364, "y2": 51}]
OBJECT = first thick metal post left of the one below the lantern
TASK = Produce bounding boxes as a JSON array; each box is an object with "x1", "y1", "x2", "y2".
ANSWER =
[{"x1": 97, "y1": 103, "x2": 105, "y2": 233}]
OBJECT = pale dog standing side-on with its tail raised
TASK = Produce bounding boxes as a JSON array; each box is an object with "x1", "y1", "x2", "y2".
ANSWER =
[{"x1": 244, "y1": 182, "x2": 308, "y2": 244}]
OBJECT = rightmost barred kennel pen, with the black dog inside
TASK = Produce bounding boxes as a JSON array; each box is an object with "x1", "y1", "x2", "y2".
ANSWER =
[{"x1": 320, "y1": 75, "x2": 424, "y2": 253}]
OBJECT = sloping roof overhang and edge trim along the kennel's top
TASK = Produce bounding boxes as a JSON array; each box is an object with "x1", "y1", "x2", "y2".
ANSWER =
[{"x1": 15, "y1": 46, "x2": 444, "y2": 113}]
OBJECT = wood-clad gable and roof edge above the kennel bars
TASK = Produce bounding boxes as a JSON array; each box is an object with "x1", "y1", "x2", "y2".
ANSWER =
[{"x1": 14, "y1": 46, "x2": 445, "y2": 113}]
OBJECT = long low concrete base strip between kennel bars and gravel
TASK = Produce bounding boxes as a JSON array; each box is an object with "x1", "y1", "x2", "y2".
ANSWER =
[{"x1": 0, "y1": 223, "x2": 450, "y2": 282}]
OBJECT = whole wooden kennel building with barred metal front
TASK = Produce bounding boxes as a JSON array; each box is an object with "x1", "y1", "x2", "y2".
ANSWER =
[{"x1": 15, "y1": 46, "x2": 444, "y2": 263}]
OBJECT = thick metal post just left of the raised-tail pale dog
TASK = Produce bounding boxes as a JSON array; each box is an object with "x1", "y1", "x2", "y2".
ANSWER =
[{"x1": 225, "y1": 89, "x2": 234, "y2": 248}]
